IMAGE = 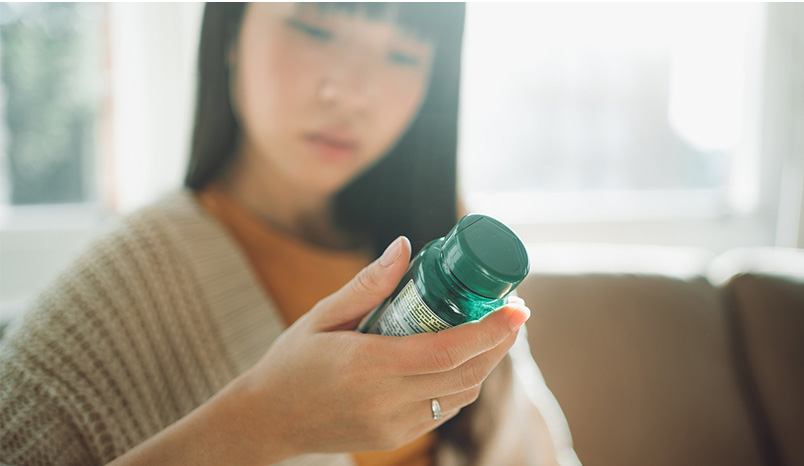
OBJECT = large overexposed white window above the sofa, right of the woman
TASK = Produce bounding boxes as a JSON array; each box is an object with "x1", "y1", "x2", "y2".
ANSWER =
[{"x1": 460, "y1": 3, "x2": 764, "y2": 224}]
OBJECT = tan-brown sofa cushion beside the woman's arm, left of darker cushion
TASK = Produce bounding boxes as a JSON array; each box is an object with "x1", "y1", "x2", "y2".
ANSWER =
[{"x1": 519, "y1": 273, "x2": 761, "y2": 466}]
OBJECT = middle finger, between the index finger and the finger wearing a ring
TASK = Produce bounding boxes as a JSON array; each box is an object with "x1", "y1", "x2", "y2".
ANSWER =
[{"x1": 404, "y1": 332, "x2": 517, "y2": 397}]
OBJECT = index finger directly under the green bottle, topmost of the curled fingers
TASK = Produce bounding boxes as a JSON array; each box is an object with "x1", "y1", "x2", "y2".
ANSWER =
[{"x1": 388, "y1": 303, "x2": 530, "y2": 375}]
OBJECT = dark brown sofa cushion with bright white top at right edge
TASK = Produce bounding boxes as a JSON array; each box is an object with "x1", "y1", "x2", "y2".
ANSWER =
[{"x1": 712, "y1": 249, "x2": 804, "y2": 464}]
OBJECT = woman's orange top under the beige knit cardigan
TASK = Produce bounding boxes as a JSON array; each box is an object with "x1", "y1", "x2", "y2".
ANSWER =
[{"x1": 198, "y1": 187, "x2": 438, "y2": 466}]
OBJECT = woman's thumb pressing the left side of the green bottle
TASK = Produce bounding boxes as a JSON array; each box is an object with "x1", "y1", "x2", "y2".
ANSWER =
[{"x1": 310, "y1": 236, "x2": 411, "y2": 330}]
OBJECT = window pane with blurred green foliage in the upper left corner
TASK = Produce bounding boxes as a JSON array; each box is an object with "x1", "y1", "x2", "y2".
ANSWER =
[{"x1": 0, "y1": 3, "x2": 107, "y2": 207}]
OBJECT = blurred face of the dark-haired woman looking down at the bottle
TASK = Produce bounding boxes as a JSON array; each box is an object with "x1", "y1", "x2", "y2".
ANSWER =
[{"x1": 231, "y1": 3, "x2": 434, "y2": 195}]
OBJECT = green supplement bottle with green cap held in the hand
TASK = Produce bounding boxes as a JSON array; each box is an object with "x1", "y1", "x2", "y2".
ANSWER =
[{"x1": 358, "y1": 214, "x2": 529, "y2": 336}]
